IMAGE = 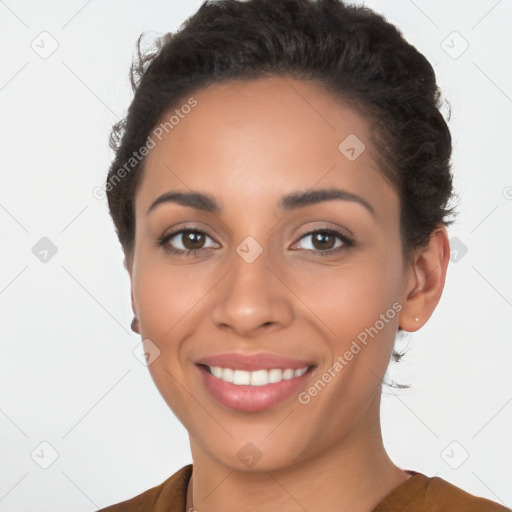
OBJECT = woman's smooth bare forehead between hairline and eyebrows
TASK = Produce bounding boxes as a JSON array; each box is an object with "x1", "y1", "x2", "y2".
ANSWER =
[{"x1": 136, "y1": 77, "x2": 397, "y2": 218}]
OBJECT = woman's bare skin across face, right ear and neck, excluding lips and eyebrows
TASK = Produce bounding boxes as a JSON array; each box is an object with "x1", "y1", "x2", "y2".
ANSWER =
[{"x1": 126, "y1": 77, "x2": 449, "y2": 512}]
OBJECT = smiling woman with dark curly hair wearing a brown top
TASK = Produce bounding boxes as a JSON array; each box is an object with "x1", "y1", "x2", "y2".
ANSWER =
[{"x1": 97, "y1": 0, "x2": 506, "y2": 512}]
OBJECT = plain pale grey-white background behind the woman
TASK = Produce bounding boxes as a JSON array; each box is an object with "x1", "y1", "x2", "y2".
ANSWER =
[{"x1": 0, "y1": 0, "x2": 512, "y2": 512}]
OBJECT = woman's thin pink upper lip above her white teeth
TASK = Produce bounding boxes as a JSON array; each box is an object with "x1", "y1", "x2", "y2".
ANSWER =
[{"x1": 196, "y1": 352, "x2": 313, "y2": 371}]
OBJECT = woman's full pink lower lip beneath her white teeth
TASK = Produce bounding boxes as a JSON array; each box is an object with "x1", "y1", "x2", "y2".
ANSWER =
[{"x1": 198, "y1": 366, "x2": 312, "y2": 412}]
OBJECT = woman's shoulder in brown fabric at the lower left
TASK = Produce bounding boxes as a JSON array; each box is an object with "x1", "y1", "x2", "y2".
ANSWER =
[{"x1": 98, "y1": 464, "x2": 192, "y2": 512}]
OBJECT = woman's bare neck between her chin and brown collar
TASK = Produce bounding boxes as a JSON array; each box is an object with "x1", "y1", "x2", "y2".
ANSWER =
[{"x1": 186, "y1": 395, "x2": 410, "y2": 512}]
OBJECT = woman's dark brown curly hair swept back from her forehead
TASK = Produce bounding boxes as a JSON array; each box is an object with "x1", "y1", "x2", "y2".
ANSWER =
[{"x1": 106, "y1": 0, "x2": 453, "y2": 264}]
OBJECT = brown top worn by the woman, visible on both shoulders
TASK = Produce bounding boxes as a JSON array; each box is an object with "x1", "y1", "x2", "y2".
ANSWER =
[{"x1": 98, "y1": 464, "x2": 511, "y2": 512}]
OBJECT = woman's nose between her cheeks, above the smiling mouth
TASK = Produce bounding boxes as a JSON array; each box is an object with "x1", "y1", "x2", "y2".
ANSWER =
[{"x1": 212, "y1": 251, "x2": 293, "y2": 338}]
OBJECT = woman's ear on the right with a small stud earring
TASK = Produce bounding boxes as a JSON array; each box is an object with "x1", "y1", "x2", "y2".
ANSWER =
[{"x1": 399, "y1": 226, "x2": 450, "y2": 332}]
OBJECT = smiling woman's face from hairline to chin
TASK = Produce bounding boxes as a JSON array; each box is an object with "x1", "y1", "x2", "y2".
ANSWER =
[{"x1": 128, "y1": 77, "x2": 416, "y2": 470}]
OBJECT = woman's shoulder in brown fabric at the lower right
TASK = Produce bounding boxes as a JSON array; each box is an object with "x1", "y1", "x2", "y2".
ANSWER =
[{"x1": 374, "y1": 473, "x2": 511, "y2": 512}]
